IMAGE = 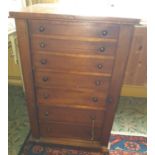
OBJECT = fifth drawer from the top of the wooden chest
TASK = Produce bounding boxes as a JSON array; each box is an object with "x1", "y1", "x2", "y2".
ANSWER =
[{"x1": 36, "y1": 88, "x2": 107, "y2": 107}]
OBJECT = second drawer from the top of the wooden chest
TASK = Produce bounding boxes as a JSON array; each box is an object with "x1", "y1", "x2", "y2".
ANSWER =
[{"x1": 32, "y1": 37, "x2": 116, "y2": 56}]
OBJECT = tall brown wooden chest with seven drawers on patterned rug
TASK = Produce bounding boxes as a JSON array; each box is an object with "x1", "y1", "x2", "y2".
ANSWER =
[{"x1": 10, "y1": 5, "x2": 139, "y2": 152}]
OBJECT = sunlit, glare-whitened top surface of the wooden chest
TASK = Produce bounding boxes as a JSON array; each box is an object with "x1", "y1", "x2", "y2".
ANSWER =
[{"x1": 10, "y1": 3, "x2": 140, "y2": 24}]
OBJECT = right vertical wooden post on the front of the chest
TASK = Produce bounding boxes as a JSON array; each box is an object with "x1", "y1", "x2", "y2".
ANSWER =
[{"x1": 103, "y1": 25, "x2": 133, "y2": 146}]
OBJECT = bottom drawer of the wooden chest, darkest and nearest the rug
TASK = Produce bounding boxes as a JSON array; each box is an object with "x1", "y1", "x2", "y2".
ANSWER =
[{"x1": 40, "y1": 122, "x2": 102, "y2": 141}]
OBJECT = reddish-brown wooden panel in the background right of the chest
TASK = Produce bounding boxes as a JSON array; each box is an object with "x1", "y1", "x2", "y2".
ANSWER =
[{"x1": 123, "y1": 26, "x2": 147, "y2": 86}]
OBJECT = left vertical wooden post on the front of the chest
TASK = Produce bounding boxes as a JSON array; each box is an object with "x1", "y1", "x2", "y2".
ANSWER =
[{"x1": 16, "y1": 19, "x2": 39, "y2": 138}]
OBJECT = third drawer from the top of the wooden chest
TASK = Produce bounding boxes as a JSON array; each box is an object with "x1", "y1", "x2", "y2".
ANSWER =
[{"x1": 33, "y1": 52, "x2": 114, "y2": 74}]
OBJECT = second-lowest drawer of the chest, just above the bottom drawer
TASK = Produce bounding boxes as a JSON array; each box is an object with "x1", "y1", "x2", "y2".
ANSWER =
[{"x1": 39, "y1": 105, "x2": 103, "y2": 126}]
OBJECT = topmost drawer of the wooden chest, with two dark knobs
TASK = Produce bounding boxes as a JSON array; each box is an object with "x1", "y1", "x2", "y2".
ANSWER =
[{"x1": 29, "y1": 20, "x2": 119, "y2": 39}]
